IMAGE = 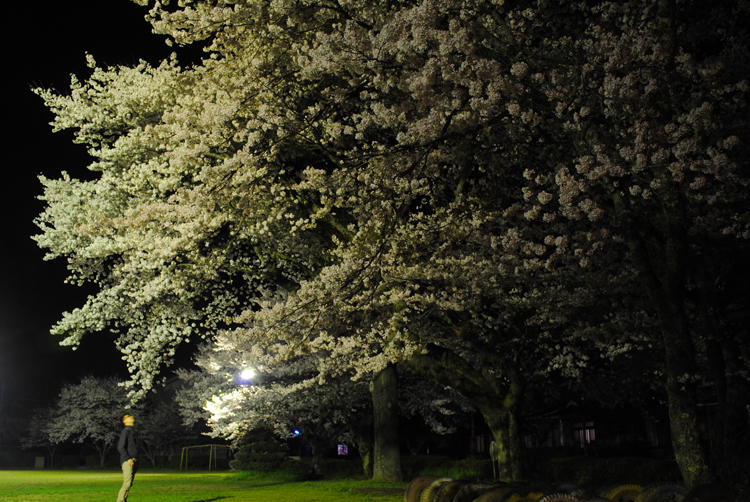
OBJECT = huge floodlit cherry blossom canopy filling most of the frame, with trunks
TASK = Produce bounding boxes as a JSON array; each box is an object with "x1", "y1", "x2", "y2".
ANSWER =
[{"x1": 36, "y1": 0, "x2": 750, "y2": 486}]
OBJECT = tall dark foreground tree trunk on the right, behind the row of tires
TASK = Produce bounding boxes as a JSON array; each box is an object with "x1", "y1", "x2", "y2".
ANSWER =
[{"x1": 648, "y1": 0, "x2": 713, "y2": 488}]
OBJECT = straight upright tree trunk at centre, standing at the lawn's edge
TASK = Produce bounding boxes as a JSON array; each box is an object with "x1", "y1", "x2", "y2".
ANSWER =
[{"x1": 370, "y1": 365, "x2": 402, "y2": 481}]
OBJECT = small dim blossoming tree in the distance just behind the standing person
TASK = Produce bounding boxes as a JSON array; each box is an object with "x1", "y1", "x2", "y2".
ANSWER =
[{"x1": 50, "y1": 376, "x2": 138, "y2": 467}]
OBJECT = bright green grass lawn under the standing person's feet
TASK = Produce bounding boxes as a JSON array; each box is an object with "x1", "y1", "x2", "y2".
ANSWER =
[{"x1": 0, "y1": 469, "x2": 407, "y2": 502}]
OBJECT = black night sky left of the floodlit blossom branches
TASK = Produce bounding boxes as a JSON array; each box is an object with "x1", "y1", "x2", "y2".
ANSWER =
[{"x1": 0, "y1": 0, "x2": 180, "y2": 400}]
